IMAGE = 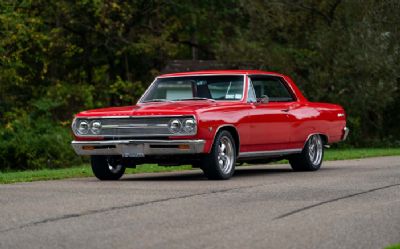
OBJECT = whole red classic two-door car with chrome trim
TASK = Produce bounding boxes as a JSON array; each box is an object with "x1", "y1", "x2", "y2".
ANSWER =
[{"x1": 72, "y1": 70, "x2": 349, "y2": 180}]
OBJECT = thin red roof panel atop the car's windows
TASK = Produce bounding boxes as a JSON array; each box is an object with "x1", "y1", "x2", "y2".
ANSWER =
[{"x1": 158, "y1": 70, "x2": 284, "y2": 78}]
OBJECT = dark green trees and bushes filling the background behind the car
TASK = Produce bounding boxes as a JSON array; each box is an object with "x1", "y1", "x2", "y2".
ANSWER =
[{"x1": 0, "y1": 0, "x2": 400, "y2": 169}]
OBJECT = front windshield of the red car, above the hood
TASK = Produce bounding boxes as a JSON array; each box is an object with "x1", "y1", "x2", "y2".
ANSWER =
[{"x1": 141, "y1": 75, "x2": 244, "y2": 102}]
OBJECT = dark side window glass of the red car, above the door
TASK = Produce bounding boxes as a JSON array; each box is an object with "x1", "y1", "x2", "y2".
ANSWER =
[{"x1": 251, "y1": 76, "x2": 294, "y2": 102}]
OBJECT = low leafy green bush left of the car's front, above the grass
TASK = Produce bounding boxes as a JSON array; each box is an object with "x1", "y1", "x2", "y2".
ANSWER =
[{"x1": 0, "y1": 114, "x2": 82, "y2": 171}]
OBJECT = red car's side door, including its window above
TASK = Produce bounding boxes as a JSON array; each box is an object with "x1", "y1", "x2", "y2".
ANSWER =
[{"x1": 248, "y1": 75, "x2": 296, "y2": 151}]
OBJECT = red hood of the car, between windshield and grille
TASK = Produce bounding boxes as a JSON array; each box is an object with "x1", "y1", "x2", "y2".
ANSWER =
[{"x1": 77, "y1": 101, "x2": 221, "y2": 117}]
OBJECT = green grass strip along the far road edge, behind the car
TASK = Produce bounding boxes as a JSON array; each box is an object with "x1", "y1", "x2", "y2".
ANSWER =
[{"x1": 0, "y1": 148, "x2": 400, "y2": 184}]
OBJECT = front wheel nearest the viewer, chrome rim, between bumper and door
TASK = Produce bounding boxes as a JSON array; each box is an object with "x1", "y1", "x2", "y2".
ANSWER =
[{"x1": 201, "y1": 130, "x2": 236, "y2": 180}]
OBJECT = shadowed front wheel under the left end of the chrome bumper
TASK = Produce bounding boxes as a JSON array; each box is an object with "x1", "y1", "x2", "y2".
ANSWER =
[{"x1": 91, "y1": 156, "x2": 125, "y2": 181}]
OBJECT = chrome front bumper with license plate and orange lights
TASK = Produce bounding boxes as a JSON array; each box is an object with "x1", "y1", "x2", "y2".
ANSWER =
[{"x1": 71, "y1": 140, "x2": 205, "y2": 157}]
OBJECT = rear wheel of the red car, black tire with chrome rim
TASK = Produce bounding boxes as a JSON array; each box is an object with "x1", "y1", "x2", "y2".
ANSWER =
[{"x1": 289, "y1": 134, "x2": 324, "y2": 171}]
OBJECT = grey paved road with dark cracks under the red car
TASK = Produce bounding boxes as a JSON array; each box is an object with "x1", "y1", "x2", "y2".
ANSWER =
[{"x1": 0, "y1": 157, "x2": 400, "y2": 249}]
